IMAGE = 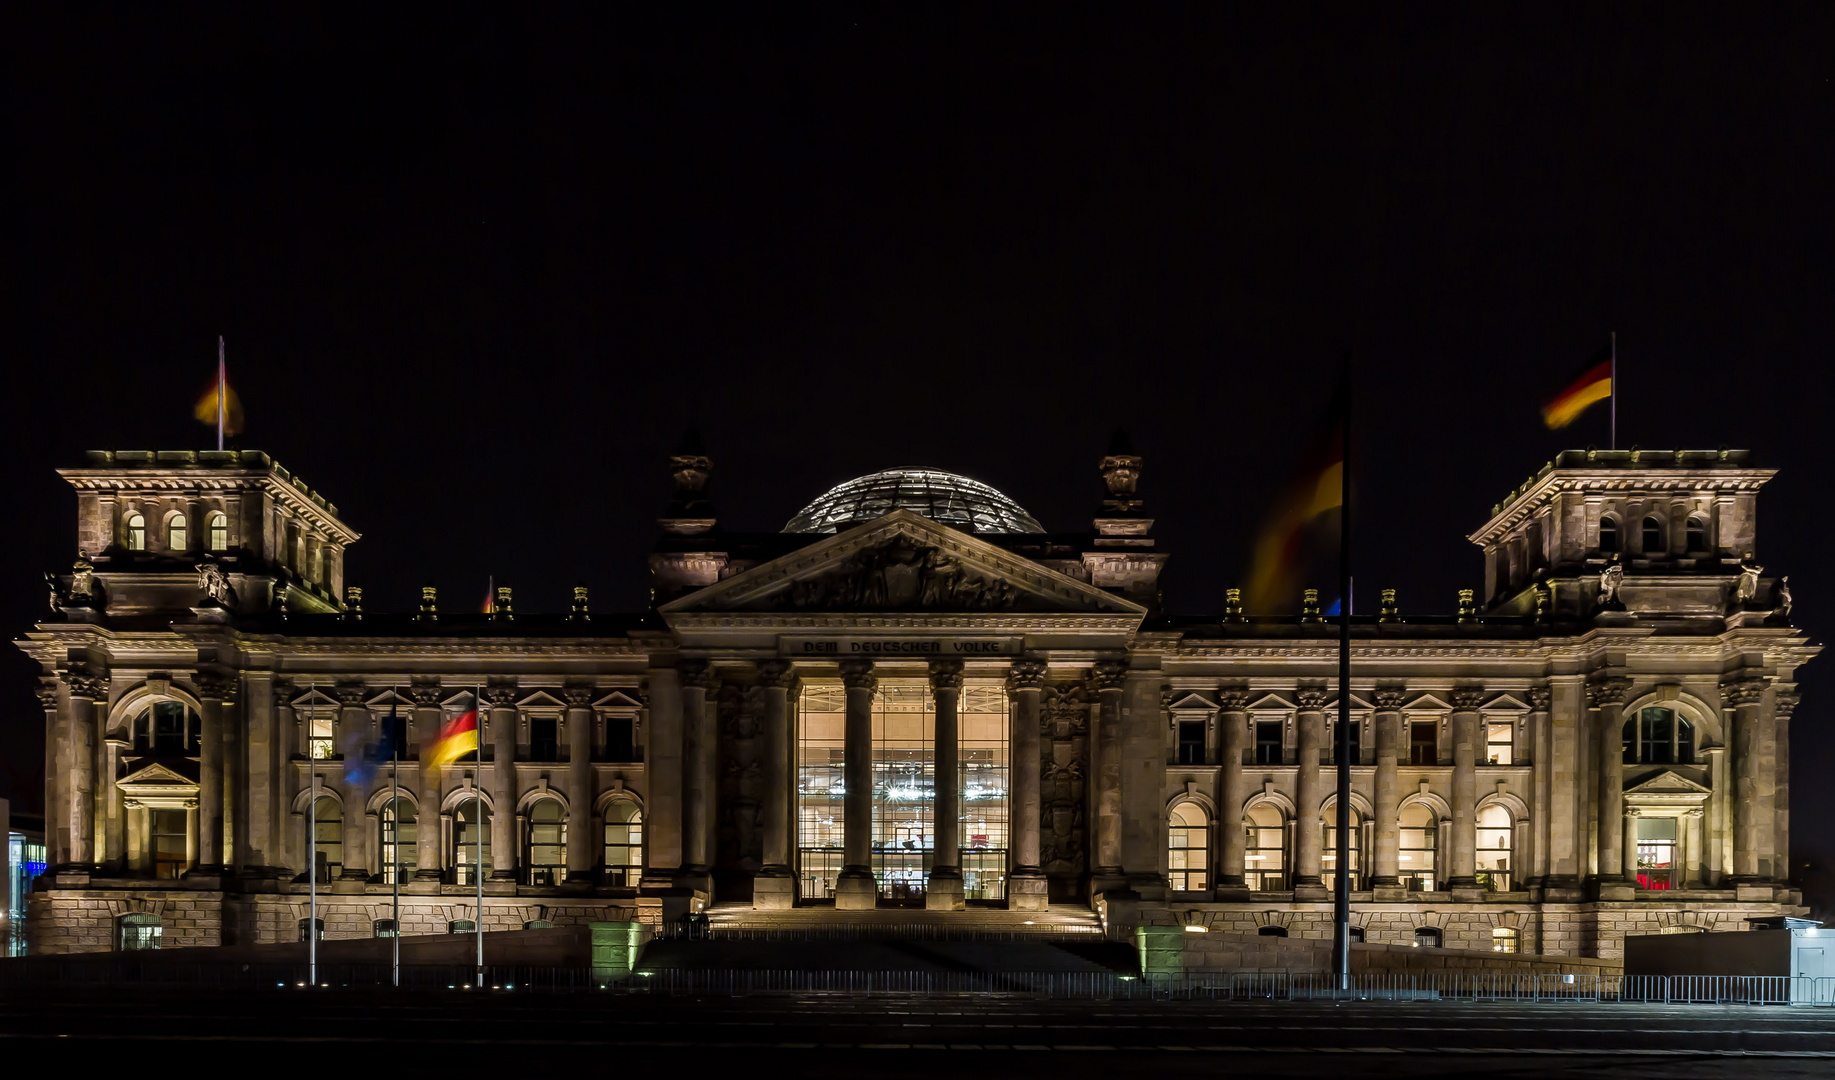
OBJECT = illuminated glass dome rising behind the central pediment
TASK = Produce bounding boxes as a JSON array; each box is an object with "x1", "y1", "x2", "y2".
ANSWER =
[{"x1": 784, "y1": 469, "x2": 1044, "y2": 532}]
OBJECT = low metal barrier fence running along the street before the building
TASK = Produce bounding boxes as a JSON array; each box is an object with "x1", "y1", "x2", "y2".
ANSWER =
[{"x1": 0, "y1": 953, "x2": 1835, "y2": 1007}]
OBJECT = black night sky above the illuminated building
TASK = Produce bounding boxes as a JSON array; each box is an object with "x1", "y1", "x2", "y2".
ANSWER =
[{"x1": 0, "y1": 12, "x2": 1835, "y2": 891}]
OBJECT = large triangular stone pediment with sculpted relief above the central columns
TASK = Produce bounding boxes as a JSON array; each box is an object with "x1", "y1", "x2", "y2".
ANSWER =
[{"x1": 661, "y1": 510, "x2": 1147, "y2": 618}]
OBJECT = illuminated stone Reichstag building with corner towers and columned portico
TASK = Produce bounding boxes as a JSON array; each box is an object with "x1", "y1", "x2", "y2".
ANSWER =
[{"x1": 17, "y1": 434, "x2": 1818, "y2": 957}]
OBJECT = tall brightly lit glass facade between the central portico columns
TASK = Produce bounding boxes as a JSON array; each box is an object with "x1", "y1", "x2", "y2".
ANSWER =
[{"x1": 796, "y1": 678, "x2": 1007, "y2": 904}]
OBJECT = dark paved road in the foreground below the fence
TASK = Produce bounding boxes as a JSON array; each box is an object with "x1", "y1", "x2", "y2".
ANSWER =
[{"x1": 0, "y1": 990, "x2": 1835, "y2": 1080}]
